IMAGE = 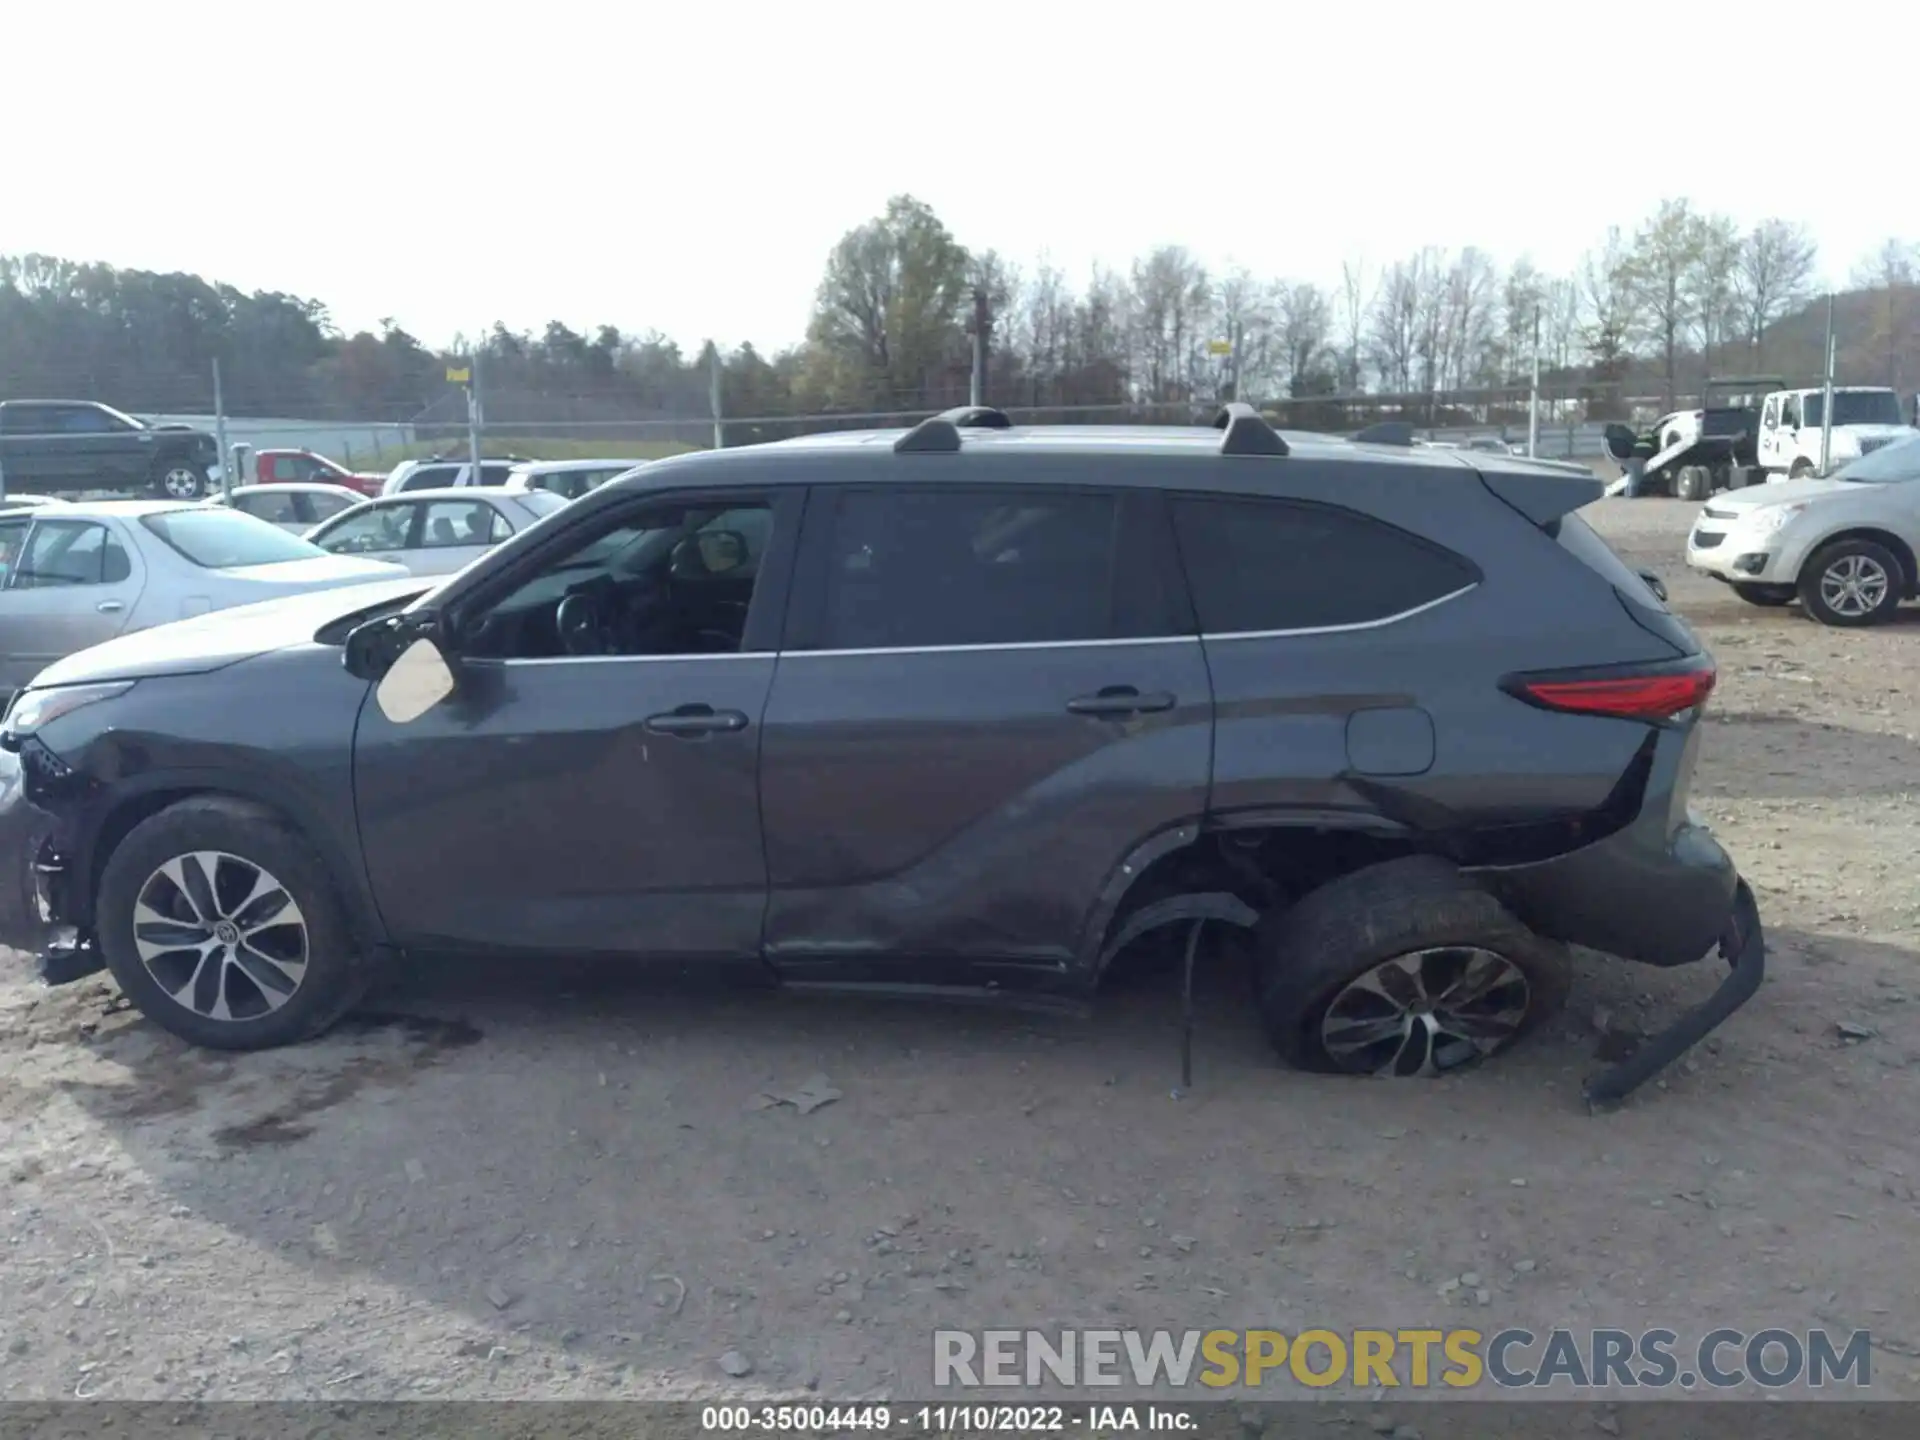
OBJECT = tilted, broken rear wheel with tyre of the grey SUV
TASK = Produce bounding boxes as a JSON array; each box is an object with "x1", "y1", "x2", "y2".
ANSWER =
[{"x1": 1256, "y1": 856, "x2": 1569, "y2": 1077}]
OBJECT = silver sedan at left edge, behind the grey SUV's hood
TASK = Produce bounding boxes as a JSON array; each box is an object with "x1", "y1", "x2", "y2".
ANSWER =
[{"x1": 0, "y1": 499, "x2": 405, "y2": 695}]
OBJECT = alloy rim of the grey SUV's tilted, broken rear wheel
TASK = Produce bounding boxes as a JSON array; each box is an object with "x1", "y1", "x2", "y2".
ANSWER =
[{"x1": 1319, "y1": 945, "x2": 1532, "y2": 1077}]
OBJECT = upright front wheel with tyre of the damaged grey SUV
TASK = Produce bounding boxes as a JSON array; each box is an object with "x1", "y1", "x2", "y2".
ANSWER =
[{"x1": 94, "y1": 797, "x2": 367, "y2": 1050}]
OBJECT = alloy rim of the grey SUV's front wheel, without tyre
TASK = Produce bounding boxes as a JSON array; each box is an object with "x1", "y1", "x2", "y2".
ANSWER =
[{"x1": 132, "y1": 851, "x2": 309, "y2": 1021}]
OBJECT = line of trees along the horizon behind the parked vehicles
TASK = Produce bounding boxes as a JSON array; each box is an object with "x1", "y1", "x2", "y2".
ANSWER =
[{"x1": 0, "y1": 196, "x2": 1920, "y2": 439}]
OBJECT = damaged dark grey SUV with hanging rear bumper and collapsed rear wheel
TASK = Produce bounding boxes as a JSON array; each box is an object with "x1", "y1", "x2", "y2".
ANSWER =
[{"x1": 0, "y1": 405, "x2": 1764, "y2": 1100}]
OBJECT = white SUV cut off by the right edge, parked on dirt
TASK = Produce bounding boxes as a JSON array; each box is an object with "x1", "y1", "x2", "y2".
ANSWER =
[{"x1": 1686, "y1": 436, "x2": 1920, "y2": 626}]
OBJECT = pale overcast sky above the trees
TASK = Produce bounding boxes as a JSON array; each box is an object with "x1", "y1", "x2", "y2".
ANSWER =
[{"x1": 0, "y1": 0, "x2": 1920, "y2": 349}]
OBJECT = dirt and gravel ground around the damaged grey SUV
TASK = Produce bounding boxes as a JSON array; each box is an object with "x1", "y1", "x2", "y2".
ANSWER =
[{"x1": 0, "y1": 499, "x2": 1920, "y2": 1400}]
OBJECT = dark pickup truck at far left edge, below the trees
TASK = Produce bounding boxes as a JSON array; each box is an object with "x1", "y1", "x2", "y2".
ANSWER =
[{"x1": 0, "y1": 399, "x2": 219, "y2": 499}]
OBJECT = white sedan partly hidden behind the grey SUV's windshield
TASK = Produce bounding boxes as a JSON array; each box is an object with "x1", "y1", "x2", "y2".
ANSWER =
[{"x1": 307, "y1": 486, "x2": 566, "y2": 574}]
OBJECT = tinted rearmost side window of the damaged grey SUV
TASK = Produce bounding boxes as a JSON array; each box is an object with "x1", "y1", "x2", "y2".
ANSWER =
[{"x1": 1173, "y1": 495, "x2": 1480, "y2": 636}]
